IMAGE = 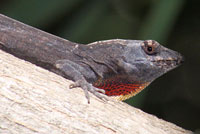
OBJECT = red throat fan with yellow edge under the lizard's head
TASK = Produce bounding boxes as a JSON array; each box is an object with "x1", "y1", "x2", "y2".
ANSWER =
[{"x1": 93, "y1": 76, "x2": 150, "y2": 101}]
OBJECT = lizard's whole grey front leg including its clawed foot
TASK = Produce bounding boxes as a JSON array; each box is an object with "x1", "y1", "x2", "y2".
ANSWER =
[{"x1": 55, "y1": 60, "x2": 107, "y2": 103}]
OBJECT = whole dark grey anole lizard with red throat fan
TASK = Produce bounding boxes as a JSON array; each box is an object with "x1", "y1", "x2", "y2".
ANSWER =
[{"x1": 0, "y1": 15, "x2": 183, "y2": 103}]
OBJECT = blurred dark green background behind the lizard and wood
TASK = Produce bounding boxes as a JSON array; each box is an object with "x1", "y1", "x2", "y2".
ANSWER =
[{"x1": 0, "y1": 0, "x2": 200, "y2": 131}]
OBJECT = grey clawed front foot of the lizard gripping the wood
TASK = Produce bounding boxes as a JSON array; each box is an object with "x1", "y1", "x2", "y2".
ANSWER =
[{"x1": 69, "y1": 80, "x2": 108, "y2": 103}]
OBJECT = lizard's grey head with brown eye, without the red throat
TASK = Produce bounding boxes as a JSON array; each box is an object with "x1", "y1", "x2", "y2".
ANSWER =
[{"x1": 118, "y1": 40, "x2": 183, "y2": 82}]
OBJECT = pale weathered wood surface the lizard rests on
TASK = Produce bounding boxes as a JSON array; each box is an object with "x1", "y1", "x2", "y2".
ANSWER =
[{"x1": 0, "y1": 51, "x2": 192, "y2": 134}]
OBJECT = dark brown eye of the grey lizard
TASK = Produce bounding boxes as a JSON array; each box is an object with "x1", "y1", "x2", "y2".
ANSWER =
[{"x1": 142, "y1": 40, "x2": 157, "y2": 55}]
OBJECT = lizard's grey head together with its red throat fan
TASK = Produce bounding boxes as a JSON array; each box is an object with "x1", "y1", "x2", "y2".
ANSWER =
[{"x1": 93, "y1": 40, "x2": 183, "y2": 100}]
